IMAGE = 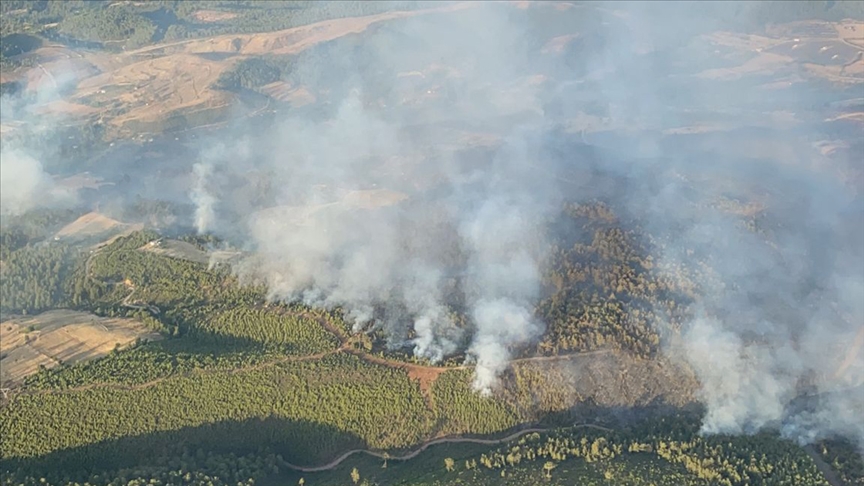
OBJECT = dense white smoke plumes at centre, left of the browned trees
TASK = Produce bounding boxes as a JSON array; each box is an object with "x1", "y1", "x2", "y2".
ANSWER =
[{"x1": 189, "y1": 0, "x2": 557, "y2": 391}]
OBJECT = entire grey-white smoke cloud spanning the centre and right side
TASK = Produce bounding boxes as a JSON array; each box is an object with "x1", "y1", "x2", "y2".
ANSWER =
[{"x1": 193, "y1": 3, "x2": 864, "y2": 443}]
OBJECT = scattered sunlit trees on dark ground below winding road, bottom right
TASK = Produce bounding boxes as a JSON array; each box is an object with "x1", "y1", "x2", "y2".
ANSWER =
[{"x1": 452, "y1": 417, "x2": 828, "y2": 486}]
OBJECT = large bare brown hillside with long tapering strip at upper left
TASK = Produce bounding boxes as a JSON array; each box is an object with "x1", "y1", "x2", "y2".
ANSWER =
[{"x1": 3, "y1": 2, "x2": 471, "y2": 138}]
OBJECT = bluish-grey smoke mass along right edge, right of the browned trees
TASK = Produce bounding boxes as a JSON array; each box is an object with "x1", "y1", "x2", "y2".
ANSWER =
[{"x1": 580, "y1": 2, "x2": 864, "y2": 447}]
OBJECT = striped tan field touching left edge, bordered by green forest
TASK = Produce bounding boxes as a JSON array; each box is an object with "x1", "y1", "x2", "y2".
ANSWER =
[{"x1": 0, "y1": 310, "x2": 160, "y2": 387}]
